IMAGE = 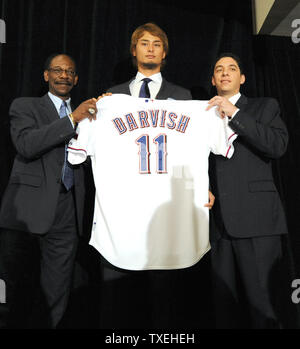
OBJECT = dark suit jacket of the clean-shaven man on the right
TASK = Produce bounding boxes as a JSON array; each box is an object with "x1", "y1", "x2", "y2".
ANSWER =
[{"x1": 210, "y1": 95, "x2": 288, "y2": 240}]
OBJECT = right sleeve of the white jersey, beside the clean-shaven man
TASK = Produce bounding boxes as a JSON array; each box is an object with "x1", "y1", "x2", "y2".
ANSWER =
[{"x1": 208, "y1": 108, "x2": 237, "y2": 159}]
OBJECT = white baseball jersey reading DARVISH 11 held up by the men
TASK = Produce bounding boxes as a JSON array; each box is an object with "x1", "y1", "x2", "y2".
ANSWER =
[{"x1": 68, "y1": 94, "x2": 237, "y2": 270}]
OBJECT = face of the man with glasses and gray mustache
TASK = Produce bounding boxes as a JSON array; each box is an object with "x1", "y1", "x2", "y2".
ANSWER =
[{"x1": 44, "y1": 55, "x2": 78, "y2": 98}]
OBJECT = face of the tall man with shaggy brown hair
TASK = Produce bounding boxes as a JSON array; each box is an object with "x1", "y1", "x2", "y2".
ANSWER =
[{"x1": 132, "y1": 31, "x2": 166, "y2": 67}]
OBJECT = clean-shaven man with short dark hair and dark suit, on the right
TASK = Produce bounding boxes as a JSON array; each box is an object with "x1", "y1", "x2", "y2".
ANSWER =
[{"x1": 209, "y1": 53, "x2": 288, "y2": 328}]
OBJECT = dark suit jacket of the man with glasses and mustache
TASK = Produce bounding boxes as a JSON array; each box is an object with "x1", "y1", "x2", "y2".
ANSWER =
[{"x1": 0, "y1": 94, "x2": 84, "y2": 234}]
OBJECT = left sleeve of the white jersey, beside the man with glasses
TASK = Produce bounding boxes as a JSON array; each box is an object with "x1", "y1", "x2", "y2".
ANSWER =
[{"x1": 68, "y1": 119, "x2": 96, "y2": 165}]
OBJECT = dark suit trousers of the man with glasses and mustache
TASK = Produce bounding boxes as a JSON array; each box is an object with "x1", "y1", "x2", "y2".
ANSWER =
[{"x1": 0, "y1": 190, "x2": 78, "y2": 328}]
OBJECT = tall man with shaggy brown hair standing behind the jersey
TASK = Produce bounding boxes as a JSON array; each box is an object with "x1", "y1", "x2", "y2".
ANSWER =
[{"x1": 96, "y1": 23, "x2": 213, "y2": 328}]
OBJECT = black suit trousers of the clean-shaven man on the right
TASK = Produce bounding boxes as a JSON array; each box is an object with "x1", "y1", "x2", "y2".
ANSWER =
[{"x1": 211, "y1": 235, "x2": 289, "y2": 329}]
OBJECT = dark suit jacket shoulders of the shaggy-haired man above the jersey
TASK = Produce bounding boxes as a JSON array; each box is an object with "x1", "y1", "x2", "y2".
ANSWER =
[{"x1": 107, "y1": 79, "x2": 192, "y2": 100}]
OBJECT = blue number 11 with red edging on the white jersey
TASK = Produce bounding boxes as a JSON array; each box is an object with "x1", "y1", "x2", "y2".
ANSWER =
[{"x1": 135, "y1": 133, "x2": 168, "y2": 174}]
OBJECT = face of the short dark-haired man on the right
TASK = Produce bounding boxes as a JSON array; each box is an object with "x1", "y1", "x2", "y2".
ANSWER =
[{"x1": 212, "y1": 57, "x2": 245, "y2": 96}]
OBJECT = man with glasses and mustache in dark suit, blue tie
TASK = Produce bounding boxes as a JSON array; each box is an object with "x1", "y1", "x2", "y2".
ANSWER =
[{"x1": 0, "y1": 54, "x2": 96, "y2": 328}]
